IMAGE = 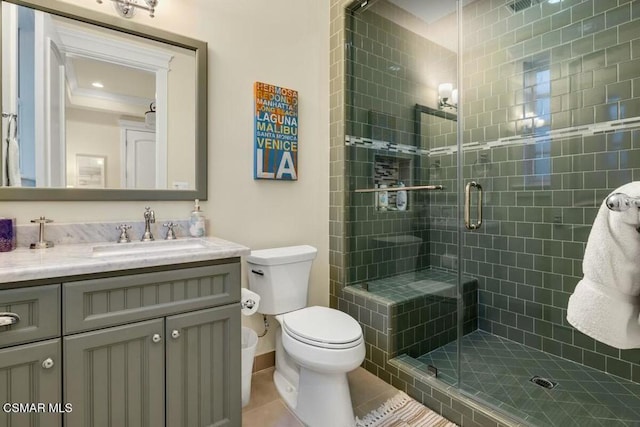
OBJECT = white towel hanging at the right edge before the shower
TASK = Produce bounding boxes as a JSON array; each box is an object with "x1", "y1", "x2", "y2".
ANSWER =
[{"x1": 567, "y1": 181, "x2": 640, "y2": 349}]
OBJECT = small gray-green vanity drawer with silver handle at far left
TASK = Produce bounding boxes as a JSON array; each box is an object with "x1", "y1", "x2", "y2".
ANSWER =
[{"x1": 0, "y1": 285, "x2": 60, "y2": 348}]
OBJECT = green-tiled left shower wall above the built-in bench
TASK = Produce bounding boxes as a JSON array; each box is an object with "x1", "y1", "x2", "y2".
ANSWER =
[{"x1": 345, "y1": 6, "x2": 456, "y2": 284}]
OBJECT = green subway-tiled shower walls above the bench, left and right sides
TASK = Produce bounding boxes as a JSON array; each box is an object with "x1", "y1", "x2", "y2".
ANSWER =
[{"x1": 346, "y1": 0, "x2": 640, "y2": 388}]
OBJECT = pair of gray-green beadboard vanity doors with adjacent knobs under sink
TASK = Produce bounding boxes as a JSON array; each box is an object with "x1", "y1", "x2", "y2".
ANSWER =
[{"x1": 64, "y1": 305, "x2": 240, "y2": 427}]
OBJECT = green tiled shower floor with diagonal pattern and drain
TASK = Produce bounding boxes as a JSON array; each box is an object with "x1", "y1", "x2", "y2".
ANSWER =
[{"x1": 418, "y1": 331, "x2": 640, "y2": 427}]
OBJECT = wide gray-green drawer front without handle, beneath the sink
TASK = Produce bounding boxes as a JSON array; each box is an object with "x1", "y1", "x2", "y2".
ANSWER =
[{"x1": 63, "y1": 263, "x2": 240, "y2": 334}]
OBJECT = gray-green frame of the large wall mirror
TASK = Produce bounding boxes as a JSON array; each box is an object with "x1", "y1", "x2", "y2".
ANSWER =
[{"x1": 0, "y1": 0, "x2": 208, "y2": 201}]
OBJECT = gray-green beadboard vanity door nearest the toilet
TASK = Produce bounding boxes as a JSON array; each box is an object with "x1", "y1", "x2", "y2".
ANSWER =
[{"x1": 166, "y1": 304, "x2": 241, "y2": 427}]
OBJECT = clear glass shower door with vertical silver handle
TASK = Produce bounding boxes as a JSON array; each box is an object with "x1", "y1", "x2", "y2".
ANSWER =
[{"x1": 458, "y1": 0, "x2": 640, "y2": 426}]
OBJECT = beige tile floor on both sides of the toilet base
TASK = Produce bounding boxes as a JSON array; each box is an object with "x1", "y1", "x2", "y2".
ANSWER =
[{"x1": 242, "y1": 368, "x2": 398, "y2": 427}]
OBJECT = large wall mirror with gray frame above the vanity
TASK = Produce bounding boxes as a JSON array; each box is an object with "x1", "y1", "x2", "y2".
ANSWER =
[{"x1": 0, "y1": 0, "x2": 207, "y2": 200}]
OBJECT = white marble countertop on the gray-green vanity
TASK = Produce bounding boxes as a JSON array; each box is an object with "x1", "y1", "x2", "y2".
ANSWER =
[{"x1": 0, "y1": 237, "x2": 250, "y2": 284}]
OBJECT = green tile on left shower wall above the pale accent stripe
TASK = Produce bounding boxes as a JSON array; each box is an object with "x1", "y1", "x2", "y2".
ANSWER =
[{"x1": 346, "y1": 8, "x2": 456, "y2": 144}]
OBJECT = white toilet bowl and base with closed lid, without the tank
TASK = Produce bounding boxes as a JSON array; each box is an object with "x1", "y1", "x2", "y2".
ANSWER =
[{"x1": 274, "y1": 307, "x2": 365, "y2": 427}]
